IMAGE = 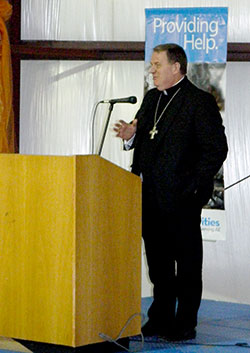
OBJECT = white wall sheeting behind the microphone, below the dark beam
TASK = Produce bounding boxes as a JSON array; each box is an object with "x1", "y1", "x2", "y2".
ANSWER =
[{"x1": 20, "y1": 61, "x2": 144, "y2": 169}]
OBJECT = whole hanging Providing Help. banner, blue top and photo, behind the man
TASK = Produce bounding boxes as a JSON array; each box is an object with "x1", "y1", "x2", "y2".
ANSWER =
[{"x1": 144, "y1": 7, "x2": 228, "y2": 240}]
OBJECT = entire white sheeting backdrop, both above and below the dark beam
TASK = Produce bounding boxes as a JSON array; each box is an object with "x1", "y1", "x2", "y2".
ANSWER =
[{"x1": 20, "y1": 0, "x2": 250, "y2": 304}]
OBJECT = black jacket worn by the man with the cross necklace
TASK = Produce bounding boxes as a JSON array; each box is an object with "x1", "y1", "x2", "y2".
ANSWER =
[{"x1": 132, "y1": 77, "x2": 228, "y2": 210}]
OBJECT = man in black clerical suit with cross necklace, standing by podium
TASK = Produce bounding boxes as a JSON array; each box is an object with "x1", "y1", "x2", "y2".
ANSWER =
[{"x1": 114, "y1": 44, "x2": 227, "y2": 340}]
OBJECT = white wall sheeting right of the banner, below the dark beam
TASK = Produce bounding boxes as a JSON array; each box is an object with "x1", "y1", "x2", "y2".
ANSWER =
[{"x1": 204, "y1": 63, "x2": 250, "y2": 304}]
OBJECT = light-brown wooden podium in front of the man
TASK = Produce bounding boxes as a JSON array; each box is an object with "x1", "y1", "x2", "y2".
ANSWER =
[{"x1": 0, "y1": 154, "x2": 141, "y2": 347}]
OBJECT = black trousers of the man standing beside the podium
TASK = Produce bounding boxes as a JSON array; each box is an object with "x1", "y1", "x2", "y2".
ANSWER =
[{"x1": 142, "y1": 187, "x2": 203, "y2": 330}]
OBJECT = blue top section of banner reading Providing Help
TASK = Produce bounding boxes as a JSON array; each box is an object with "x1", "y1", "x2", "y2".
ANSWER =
[{"x1": 145, "y1": 7, "x2": 228, "y2": 63}]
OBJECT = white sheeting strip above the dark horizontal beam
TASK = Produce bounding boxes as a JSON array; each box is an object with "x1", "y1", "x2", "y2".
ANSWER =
[{"x1": 21, "y1": 0, "x2": 250, "y2": 42}]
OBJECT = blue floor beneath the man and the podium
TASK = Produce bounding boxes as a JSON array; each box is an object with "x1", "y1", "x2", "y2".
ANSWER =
[{"x1": 0, "y1": 298, "x2": 250, "y2": 353}]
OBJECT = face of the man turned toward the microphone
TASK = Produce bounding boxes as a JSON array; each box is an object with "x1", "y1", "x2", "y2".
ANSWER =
[{"x1": 150, "y1": 52, "x2": 182, "y2": 91}]
